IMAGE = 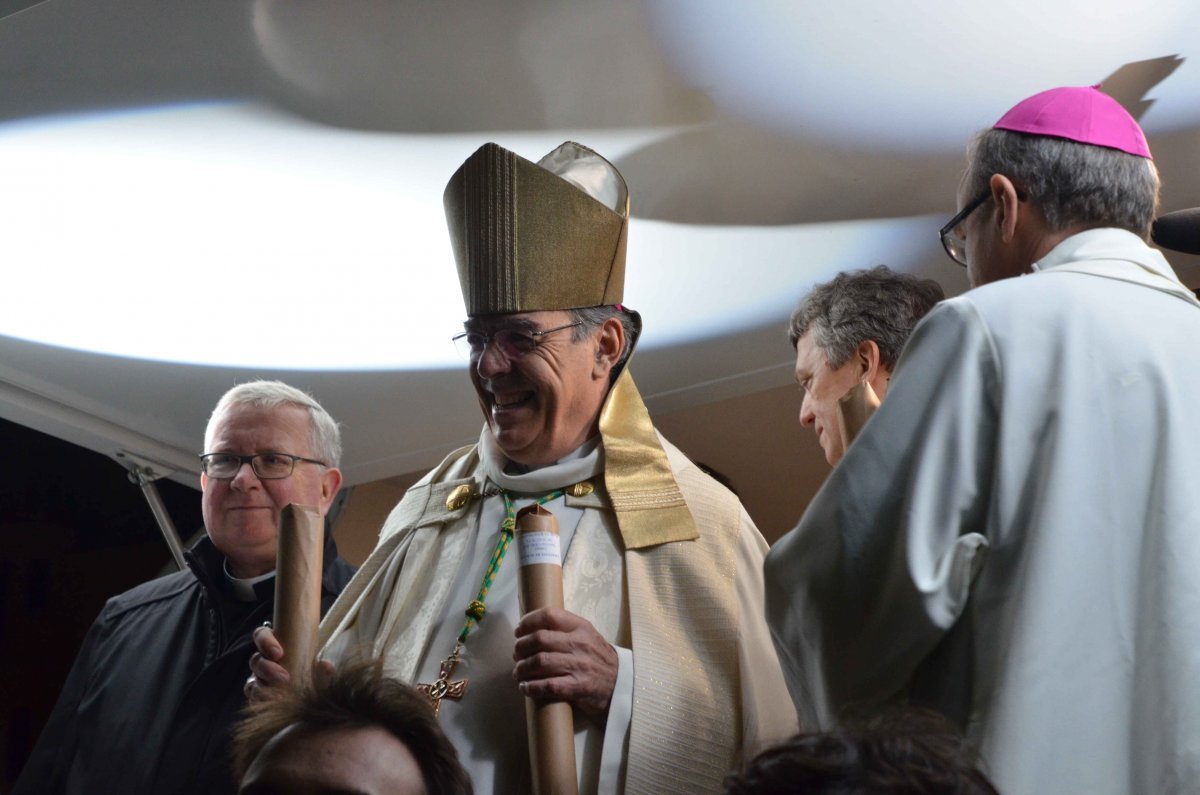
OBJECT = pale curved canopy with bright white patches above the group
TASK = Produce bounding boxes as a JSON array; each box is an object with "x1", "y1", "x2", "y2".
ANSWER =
[{"x1": 0, "y1": 0, "x2": 1200, "y2": 492}]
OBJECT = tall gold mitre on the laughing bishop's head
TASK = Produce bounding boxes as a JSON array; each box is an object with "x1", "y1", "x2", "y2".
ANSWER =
[{"x1": 443, "y1": 141, "x2": 629, "y2": 317}]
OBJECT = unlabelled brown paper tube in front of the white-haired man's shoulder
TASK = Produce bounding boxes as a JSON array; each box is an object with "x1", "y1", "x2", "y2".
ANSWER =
[{"x1": 272, "y1": 504, "x2": 325, "y2": 685}]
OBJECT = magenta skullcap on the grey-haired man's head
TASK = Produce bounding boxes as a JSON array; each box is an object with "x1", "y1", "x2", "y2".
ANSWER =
[{"x1": 995, "y1": 85, "x2": 1150, "y2": 159}]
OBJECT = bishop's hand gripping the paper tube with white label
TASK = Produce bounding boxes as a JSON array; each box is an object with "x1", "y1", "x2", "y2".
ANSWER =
[{"x1": 512, "y1": 608, "x2": 617, "y2": 725}]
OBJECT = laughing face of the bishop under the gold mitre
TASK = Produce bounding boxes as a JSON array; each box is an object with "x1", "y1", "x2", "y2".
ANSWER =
[{"x1": 467, "y1": 311, "x2": 611, "y2": 466}]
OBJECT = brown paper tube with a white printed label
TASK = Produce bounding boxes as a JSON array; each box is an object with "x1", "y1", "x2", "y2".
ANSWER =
[{"x1": 516, "y1": 504, "x2": 578, "y2": 795}]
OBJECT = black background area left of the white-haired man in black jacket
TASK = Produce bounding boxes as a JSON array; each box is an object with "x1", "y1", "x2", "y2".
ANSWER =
[{"x1": 0, "y1": 419, "x2": 204, "y2": 791}]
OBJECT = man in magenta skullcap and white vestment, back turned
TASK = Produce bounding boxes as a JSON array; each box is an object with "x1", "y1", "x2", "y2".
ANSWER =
[{"x1": 767, "y1": 88, "x2": 1200, "y2": 795}]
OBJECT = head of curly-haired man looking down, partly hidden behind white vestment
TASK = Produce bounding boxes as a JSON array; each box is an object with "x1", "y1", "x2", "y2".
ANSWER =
[{"x1": 787, "y1": 265, "x2": 946, "y2": 466}]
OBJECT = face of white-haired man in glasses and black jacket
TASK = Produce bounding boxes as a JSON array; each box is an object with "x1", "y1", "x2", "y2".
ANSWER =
[{"x1": 200, "y1": 404, "x2": 341, "y2": 578}]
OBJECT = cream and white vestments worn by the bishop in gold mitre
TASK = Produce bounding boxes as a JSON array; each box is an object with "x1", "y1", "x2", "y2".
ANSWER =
[{"x1": 322, "y1": 428, "x2": 796, "y2": 793}]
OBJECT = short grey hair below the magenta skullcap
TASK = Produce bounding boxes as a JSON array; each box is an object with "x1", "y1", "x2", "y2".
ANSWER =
[{"x1": 965, "y1": 130, "x2": 1159, "y2": 240}]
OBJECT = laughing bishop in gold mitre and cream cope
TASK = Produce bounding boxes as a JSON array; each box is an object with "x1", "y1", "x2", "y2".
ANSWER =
[{"x1": 322, "y1": 143, "x2": 796, "y2": 795}]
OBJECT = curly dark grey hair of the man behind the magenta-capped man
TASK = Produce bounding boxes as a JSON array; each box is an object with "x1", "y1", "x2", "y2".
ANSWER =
[{"x1": 787, "y1": 265, "x2": 946, "y2": 371}]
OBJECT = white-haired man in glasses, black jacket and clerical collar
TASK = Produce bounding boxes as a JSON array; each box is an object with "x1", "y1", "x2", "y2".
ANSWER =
[{"x1": 13, "y1": 381, "x2": 354, "y2": 794}]
